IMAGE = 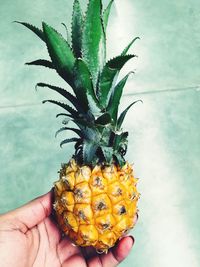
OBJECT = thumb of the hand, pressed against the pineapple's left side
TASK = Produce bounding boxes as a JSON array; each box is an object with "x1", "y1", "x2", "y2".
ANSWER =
[{"x1": 6, "y1": 191, "x2": 52, "y2": 229}]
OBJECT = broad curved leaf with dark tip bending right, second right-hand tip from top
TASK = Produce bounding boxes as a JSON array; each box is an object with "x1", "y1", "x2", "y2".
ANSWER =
[{"x1": 98, "y1": 55, "x2": 135, "y2": 108}]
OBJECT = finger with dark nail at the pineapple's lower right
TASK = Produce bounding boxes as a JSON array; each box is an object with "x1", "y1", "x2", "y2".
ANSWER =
[{"x1": 99, "y1": 236, "x2": 134, "y2": 267}]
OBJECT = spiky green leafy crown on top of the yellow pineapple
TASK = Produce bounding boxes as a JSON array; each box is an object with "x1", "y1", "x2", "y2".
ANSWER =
[{"x1": 15, "y1": 0, "x2": 139, "y2": 167}]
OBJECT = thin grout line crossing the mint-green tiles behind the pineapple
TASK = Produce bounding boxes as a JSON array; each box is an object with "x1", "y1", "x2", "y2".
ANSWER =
[{"x1": 0, "y1": 85, "x2": 200, "y2": 109}]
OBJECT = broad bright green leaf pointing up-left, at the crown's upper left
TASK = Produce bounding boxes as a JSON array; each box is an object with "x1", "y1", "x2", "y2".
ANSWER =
[{"x1": 42, "y1": 22, "x2": 75, "y2": 85}]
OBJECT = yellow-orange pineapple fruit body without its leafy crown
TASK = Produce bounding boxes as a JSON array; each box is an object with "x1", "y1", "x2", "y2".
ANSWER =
[{"x1": 53, "y1": 159, "x2": 139, "y2": 253}]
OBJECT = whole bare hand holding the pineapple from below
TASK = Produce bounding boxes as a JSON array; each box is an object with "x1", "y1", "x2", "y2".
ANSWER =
[{"x1": 0, "y1": 192, "x2": 134, "y2": 267}]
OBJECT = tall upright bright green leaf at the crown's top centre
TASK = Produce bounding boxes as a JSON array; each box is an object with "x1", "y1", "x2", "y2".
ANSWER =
[{"x1": 82, "y1": 0, "x2": 106, "y2": 87}]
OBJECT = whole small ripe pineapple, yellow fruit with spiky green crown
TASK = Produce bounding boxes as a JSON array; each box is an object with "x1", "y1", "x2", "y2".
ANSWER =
[{"x1": 16, "y1": 0, "x2": 139, "y2": 252}]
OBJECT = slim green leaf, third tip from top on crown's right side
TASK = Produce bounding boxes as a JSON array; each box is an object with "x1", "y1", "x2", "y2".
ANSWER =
[{"x1": 106, "y1": 72, "x2": 133, "y2": 124}]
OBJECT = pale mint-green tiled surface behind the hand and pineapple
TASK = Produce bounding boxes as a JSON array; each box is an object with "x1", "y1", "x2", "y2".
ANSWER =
[{"x1": 0, "y1": 0, "x2": 200, "y2": 267}]
